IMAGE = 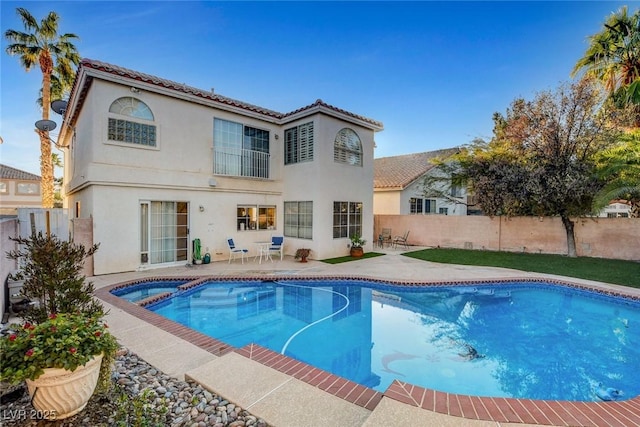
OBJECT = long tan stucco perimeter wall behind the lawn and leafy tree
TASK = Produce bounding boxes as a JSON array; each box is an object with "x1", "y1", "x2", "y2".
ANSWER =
[{"x1": 374, "y1": 215, "x2": 640, "y2": 261}]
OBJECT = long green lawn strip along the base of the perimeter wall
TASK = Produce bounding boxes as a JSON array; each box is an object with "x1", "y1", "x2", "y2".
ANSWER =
[{"x1": 403, "y1": 248, "x2": 640, "y2": 288}]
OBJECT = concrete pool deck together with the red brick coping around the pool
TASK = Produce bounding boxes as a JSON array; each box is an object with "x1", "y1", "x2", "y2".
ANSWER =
[{"x1": 90, "y1": 248, "x2": 640, "y2": 427}]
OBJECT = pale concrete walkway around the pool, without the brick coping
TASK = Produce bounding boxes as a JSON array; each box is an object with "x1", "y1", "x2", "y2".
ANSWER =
[{"x1": 91, "y1": 248, "x2": 640, "y2": 427}]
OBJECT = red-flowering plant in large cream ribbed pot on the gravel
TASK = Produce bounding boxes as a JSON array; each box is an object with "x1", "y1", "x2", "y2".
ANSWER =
[{"x1": 0, "y1": 312, "x2": 118, "y2": 420}]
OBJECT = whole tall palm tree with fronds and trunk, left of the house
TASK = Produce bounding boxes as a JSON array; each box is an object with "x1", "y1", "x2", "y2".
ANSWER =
[{"x1": 4, "y1": 8, "x2": 80, "y2": 208}]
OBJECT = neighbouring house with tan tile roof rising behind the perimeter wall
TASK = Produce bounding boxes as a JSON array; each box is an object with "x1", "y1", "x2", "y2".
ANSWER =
[{"x1": 373, "y1": 148, "x2": 467, "y2": 215}]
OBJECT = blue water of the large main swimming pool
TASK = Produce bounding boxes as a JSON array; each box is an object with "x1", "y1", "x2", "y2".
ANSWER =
[{"x1": 121, "y1": 280, "x2": 640, "y2": 401}]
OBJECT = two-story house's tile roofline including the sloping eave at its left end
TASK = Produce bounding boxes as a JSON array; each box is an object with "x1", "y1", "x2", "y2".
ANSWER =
[{"x1": 60, "y1": 58, "x2": 383, "y2": 144}]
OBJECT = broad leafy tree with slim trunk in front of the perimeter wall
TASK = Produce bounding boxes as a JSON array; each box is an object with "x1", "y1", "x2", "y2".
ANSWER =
[{"x1": 456, "y1": 80, "x2": 618, "y2": 257}]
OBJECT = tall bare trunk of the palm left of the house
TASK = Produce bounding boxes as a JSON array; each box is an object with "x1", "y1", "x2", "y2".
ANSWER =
[{"x1": 37, "y1": 51, "x2": 54, "y2": 209}]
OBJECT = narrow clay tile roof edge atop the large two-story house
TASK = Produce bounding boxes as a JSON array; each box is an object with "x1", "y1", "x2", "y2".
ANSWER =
[{"x1": 74, "y1": 58, "x2": 383, "y2": 130}]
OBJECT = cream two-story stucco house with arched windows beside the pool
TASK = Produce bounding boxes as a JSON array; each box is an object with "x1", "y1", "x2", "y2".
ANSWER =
[{"x1": 58, "y1": 59, "x2": 383, "y2": 274}]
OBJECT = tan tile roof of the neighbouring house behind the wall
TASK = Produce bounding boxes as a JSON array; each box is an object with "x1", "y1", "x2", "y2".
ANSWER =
[{"x1": 373, "y1": 148, "x2": 458, "y2": 190}]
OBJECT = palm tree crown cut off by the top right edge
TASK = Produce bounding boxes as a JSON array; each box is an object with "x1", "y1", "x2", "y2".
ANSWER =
[{"x1": 571, "y1": 6, "x2": 640, "y2": 123}]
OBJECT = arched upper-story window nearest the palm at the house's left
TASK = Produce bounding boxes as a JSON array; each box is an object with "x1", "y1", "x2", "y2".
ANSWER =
[{"x1": 108, "y1": 96, "x2": 156, "y2": 147}]
